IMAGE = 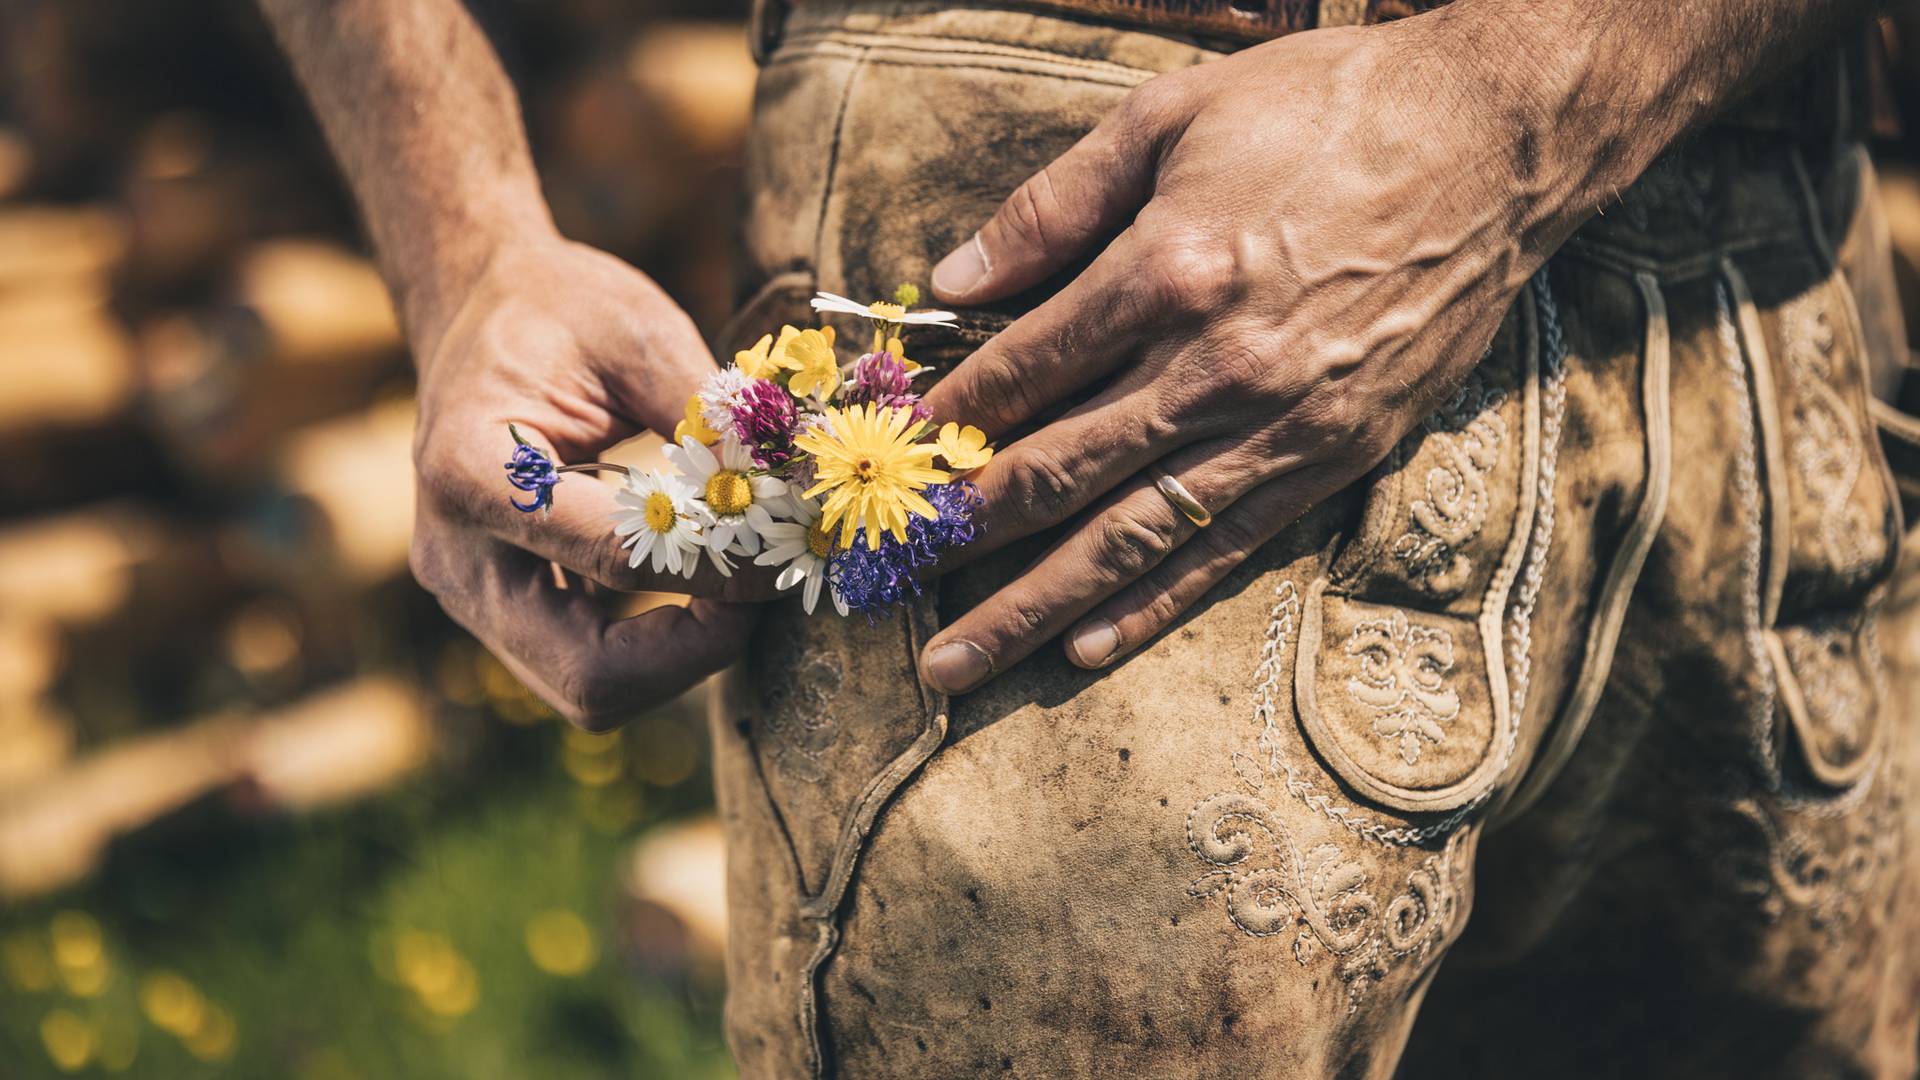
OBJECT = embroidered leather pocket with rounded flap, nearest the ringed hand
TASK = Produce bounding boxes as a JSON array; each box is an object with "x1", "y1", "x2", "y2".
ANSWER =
[{"x1": 1294, "y1": 286, "x2": 1540, "y2": 813}]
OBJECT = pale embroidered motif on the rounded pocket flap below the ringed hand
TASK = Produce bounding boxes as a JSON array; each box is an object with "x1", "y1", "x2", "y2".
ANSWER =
[{"x1": 1344, "y1": 609, "x2": 1459, "y2": 765}]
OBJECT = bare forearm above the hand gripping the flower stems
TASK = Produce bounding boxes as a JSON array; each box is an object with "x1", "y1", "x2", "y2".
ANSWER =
[{"x1": 259, "y1": 0, "x2": 553, "y2": 363}]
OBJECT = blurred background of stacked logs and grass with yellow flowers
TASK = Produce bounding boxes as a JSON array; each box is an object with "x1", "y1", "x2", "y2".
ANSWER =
[{"x1": 0, "y1": 0, "x2": 755, "y2": 1080}]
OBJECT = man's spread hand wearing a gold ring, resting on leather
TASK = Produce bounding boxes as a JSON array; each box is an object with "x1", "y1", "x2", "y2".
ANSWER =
[{"x1": 922, "y1": 17, "x2": 1571, "y2": 694}]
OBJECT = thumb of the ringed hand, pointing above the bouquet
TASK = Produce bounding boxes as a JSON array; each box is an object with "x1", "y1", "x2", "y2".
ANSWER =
[{"x1": 933, "y1": 76, "x2": 1160, "y2": 304}]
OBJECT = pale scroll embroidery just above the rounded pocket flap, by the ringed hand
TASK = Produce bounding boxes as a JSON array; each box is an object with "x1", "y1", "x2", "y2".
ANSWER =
[{"x1": 1392, "y1": 373, "x2": 1507, "y2": 596}]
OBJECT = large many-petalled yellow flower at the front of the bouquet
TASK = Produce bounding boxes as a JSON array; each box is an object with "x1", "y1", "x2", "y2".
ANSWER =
[{"x1": 793, "y1": 404, "x2": 948, "y2": 548}]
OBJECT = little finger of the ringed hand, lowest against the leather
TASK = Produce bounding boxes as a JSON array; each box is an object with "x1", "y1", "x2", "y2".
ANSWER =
[{"x1": 1066, "y1": 465, "x2": 1352, "y2": 669}]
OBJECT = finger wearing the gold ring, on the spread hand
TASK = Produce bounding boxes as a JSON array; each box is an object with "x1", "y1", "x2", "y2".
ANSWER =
[{"x1": 922, "y1": 440, "x2": 1258, "y2": 694}]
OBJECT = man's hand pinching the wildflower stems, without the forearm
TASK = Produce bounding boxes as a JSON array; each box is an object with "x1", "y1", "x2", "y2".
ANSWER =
[{"x1": 411, "y1": 238, "x2": 774, "y2": 730}]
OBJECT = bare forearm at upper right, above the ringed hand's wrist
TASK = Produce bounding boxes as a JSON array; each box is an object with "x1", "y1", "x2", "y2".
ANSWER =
[{"x1": 1432, "y1": 0, "x2": 1874, "y2": 258}]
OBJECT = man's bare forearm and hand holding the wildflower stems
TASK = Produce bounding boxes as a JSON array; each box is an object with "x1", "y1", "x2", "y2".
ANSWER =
[{"x1": 261, "y1": 0, "x2": 770, "y2": 728}]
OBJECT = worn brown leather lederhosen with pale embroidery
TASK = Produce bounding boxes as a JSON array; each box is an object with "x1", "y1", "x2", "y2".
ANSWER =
[{"x1": 714, "y1": 4, "x2": 1920, "y2": 1078}]
